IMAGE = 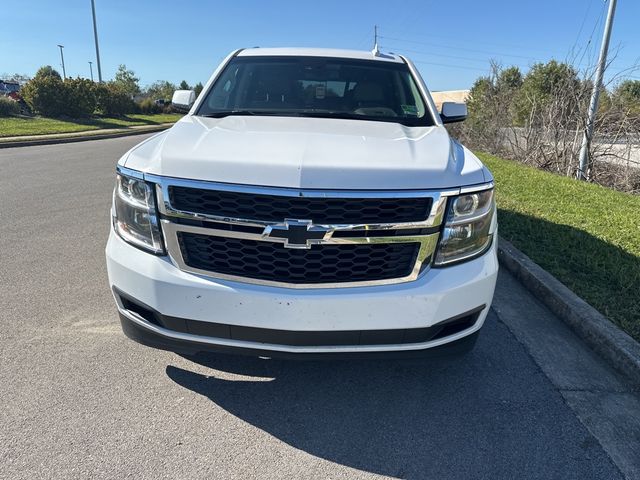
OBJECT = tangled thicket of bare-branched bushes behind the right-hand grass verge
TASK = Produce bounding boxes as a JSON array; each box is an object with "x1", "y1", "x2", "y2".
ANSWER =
[{"x1": 452, "y1": 61, "x2": 640, "y2": 193}]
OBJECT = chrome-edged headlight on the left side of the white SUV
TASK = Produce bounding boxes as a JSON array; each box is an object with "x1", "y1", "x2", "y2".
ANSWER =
[{"x1": 112, "y1": 174, "x2": 165, "y2": 254}]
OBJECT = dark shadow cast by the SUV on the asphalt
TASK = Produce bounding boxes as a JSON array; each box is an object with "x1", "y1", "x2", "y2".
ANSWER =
[{"x1": 166, "y1": 312, "x2": 615, "y2": 479}]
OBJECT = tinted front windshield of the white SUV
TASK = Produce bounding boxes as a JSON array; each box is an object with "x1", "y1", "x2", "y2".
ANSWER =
[{"x1": 196, "y1": 56, "x2": 433, "y2": 126}]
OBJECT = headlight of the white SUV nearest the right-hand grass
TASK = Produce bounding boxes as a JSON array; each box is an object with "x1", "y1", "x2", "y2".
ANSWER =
[{"x1": 434, "y1": 189, "x2": 495, "y2": 266}]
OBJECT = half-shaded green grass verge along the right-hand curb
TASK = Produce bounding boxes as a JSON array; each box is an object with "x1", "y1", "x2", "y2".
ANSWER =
[{"x1": 479, "y1": 154, "x2": 640, "y2": 341}]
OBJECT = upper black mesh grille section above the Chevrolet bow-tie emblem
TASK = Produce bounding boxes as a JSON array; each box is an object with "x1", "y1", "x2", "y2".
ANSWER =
[{"x1": 169, "y1": 185, "x2": 432, "y2": 225}]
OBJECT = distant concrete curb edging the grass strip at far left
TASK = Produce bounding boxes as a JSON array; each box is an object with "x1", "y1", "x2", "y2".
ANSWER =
[{"x1": 0, "y1": 123, "x2": 173, "y2": 148}]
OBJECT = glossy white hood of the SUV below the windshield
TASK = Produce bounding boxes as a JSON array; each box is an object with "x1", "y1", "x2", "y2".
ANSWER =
[{"x1": 124, "y1": 116, "x2": 485, "y2": 190}]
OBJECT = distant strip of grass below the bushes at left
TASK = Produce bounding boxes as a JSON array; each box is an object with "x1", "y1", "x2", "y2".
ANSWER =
[{"x1": 0, "y1": 113, "x2": 182, "y2": 138}]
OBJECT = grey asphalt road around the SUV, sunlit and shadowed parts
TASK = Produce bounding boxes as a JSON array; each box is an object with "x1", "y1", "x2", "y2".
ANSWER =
[{"x1": 0, "y1": 137, "x2": 634, "y2": 480}]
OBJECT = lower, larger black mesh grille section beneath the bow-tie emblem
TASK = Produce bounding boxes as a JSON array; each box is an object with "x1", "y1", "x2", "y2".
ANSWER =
[{"x1": 177, "y1": 232, "x2": 420, "y2": 284}]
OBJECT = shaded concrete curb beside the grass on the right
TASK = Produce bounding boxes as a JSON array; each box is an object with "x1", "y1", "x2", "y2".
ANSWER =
[{"x1": 498, "y1": 238, "x2": 640, "y2": 385}]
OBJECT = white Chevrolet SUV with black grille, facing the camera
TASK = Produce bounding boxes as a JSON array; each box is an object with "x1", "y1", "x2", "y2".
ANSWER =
[{"x1": 106, "y1": 48, "x2": 498, "y2": 356}]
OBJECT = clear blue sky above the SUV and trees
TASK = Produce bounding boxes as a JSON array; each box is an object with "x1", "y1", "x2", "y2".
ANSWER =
[{"x1": 0, "y1": 0, "x2": 640, "y2": 90}]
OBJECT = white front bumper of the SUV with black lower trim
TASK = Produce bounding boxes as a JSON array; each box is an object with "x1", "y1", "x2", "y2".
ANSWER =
[{"x1": 106, "y1": 231, "x2": 498, "y2": 356}]
